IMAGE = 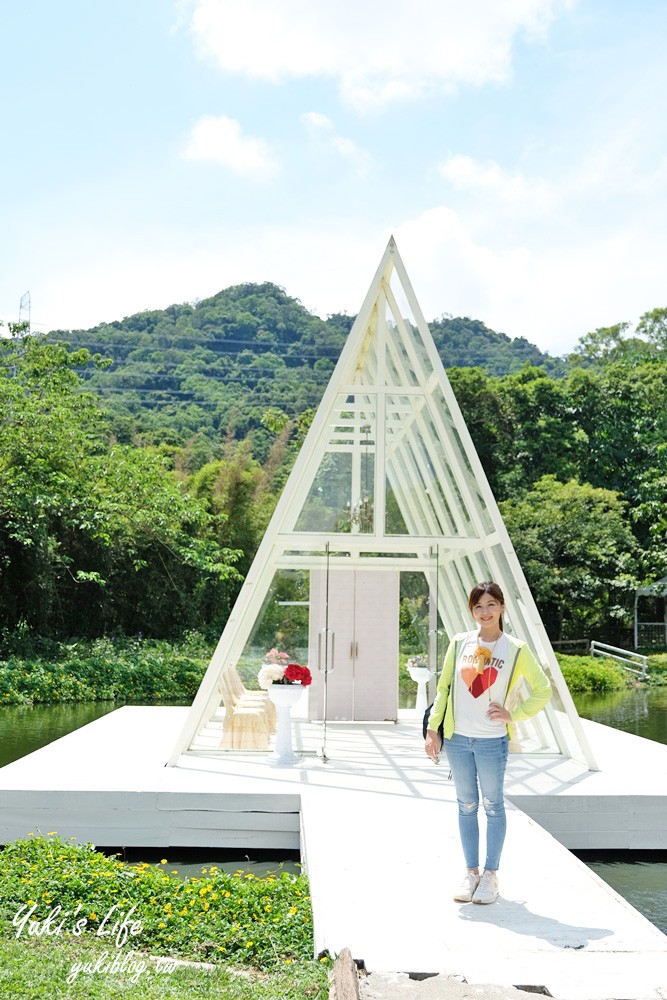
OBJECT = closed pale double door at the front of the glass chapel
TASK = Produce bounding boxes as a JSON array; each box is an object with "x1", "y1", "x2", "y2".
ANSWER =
[{"x1": 309, "y1": 563, "x2": 399, "y2": 722}]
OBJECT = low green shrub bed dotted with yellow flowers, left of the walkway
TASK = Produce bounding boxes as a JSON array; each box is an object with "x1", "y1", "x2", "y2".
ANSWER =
[{"x1": 0, "y1": 834, "x2": 314, "y2": 969}]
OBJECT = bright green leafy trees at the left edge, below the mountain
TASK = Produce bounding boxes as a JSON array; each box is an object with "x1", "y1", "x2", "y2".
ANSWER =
[{"x1": 0, "y1": 337, "x2": 237, "y2": 636}]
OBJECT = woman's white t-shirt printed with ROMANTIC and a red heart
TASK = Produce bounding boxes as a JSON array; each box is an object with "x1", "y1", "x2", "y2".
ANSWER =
[{"x1": 454, "y1": 632, "x2": 510, "y2": 739}]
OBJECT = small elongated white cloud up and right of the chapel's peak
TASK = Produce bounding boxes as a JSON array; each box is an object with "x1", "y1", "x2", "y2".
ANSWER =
[{"x1": 439, "y1": 155, "x2": 557, "y2": 212}]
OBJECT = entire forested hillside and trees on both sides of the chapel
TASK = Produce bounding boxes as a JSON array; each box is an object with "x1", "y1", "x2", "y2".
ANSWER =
[{"x1": 0, "y1": 284, "x2": 667, "y2": 645}]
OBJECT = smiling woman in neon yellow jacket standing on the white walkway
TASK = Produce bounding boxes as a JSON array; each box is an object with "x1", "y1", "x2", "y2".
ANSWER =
[{"x1": 425, "y1": 580, "x2": 551, "y2": 903}]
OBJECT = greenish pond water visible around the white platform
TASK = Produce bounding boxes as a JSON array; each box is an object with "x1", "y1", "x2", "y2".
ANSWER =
[{"x1": 0, "y1": 688, "x2": 667, "y2": 933}]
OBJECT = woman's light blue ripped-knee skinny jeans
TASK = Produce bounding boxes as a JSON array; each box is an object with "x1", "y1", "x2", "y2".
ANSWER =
[{"x1": 445, "y1": 733, "x2": 508, "y2": 871}]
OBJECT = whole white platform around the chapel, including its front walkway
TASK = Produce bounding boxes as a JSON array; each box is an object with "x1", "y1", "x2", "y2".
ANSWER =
[{"x1": 0, "y1": 708, "x2": 667, "y2": 1000}]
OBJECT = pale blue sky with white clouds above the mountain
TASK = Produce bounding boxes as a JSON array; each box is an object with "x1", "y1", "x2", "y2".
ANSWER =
[{"x1": 0, "y1": 0, "x2": 667, "y2": 354}]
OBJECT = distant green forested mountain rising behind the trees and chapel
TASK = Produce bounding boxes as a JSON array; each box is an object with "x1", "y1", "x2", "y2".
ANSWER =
[{"x1": 46, "y1": 282, "x2": 562, "y2": 461}]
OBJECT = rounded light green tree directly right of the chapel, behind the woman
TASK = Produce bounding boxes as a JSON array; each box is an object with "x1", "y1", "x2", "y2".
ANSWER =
[{"x1": 500, "y1": 475, "x2": 638, "y2": 641}]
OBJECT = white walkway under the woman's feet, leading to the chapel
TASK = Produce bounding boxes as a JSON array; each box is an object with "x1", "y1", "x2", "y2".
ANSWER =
[{"x1": 302, "y1": 724, "x2": 667, "y2": 1000}]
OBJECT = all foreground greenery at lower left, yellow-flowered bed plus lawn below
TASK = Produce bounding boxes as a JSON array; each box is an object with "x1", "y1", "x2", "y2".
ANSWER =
[{"x1": 0, "y1": 834, "x2": 329, "y2": 1000}]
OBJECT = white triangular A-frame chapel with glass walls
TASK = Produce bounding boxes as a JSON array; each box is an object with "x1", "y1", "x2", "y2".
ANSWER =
[{"x1": 169, "y1": 238, "x2": 596, "y2": 768}]
